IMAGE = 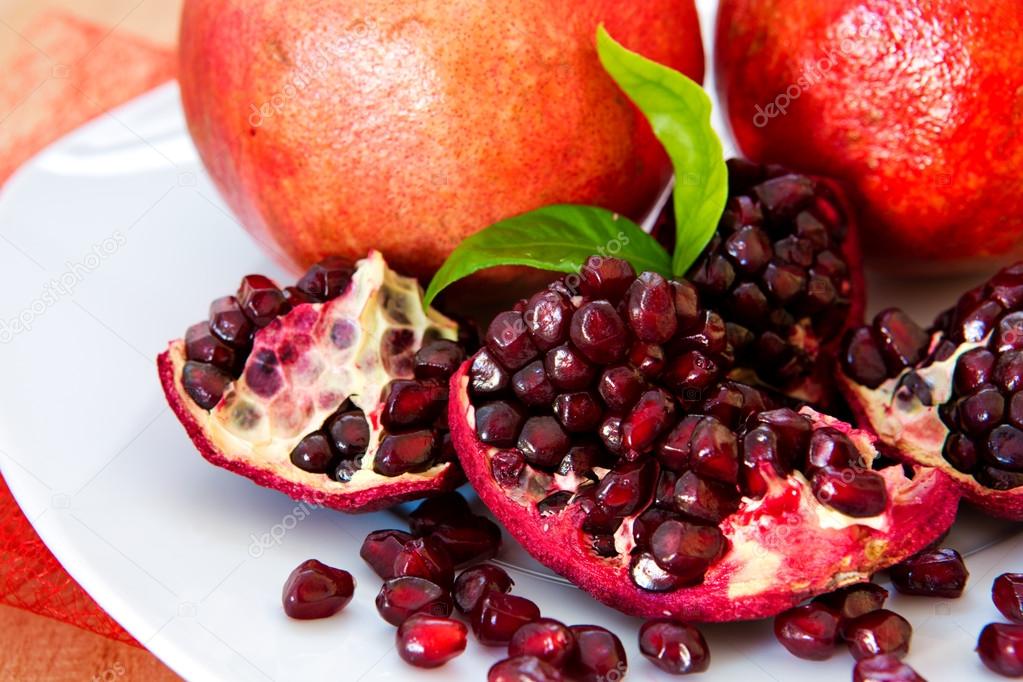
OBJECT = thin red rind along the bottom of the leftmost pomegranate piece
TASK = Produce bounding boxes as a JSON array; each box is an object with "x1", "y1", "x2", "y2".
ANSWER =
[{"x1": 157, "y1": 347, "x2": 463, "y2": 513}]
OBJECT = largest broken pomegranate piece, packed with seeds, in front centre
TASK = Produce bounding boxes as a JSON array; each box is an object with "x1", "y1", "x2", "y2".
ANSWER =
[{"x1": 449, "y1": 258, "x2": 958, "y2": 621}]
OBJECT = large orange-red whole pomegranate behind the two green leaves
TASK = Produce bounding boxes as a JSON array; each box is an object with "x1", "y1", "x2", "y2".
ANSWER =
[{"x1": 179, "y1": 0, "x2": 704, "y2": 277}]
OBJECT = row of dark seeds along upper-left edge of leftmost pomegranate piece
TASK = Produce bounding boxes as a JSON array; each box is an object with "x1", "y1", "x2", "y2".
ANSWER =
[{"x1": 181, "y1": 258, "x2": 354, "y2": 410}]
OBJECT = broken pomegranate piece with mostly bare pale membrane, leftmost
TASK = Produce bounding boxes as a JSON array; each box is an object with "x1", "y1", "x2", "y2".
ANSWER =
[{"x1": 158, "y1": 253, "x2": 462, "y2": 511}]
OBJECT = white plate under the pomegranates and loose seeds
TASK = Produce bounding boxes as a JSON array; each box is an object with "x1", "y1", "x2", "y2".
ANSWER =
[{"x1": 0, "y1": 2, "x2": 1023, "y2": 682}]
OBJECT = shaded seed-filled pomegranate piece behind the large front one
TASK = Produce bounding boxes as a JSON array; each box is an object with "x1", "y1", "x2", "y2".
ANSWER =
[{"x1": 650, "y1": 158, "x2": 865, "y2": 406}]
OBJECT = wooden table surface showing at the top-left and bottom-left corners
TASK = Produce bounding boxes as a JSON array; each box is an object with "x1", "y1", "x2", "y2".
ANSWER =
[{"x1": 0, "y1": 0, "x2": 181, "y2": 682}]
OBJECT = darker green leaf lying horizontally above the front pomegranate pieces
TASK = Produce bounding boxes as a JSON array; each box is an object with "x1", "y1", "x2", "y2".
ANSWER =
[{"x1": 424, "y1": 203, "x2": 671, "y2": 306}]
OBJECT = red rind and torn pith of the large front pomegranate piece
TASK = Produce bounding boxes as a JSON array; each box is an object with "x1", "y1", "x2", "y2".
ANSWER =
[{"x1": 448, "y1": 361, "x2": 959, "y2": 622}]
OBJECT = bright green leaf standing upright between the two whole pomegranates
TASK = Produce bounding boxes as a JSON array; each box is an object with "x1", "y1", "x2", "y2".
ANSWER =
[{"x1": 596, "y1": 26, "x2": 728, "y2": 276}]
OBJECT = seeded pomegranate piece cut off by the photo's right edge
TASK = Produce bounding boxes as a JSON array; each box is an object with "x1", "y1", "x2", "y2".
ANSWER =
[{"x1": 839, "y1": 263, "x2": 1023, "y2": 519}]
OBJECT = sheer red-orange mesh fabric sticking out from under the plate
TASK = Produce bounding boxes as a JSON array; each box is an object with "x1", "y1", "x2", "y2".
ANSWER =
[{"x1": 0, "y1": 13, "x2": 175, "y2": 643}]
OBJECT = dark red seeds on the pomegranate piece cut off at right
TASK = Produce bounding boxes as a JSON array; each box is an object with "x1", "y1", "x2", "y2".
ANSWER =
[{"x1": 842, "y1": 264, "x2": 1023, "y2": 490}]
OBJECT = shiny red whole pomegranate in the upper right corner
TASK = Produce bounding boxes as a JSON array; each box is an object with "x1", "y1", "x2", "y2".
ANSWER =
[{"x1": 715, "y1": 0, "x2": 1023, "y2": 272}]
